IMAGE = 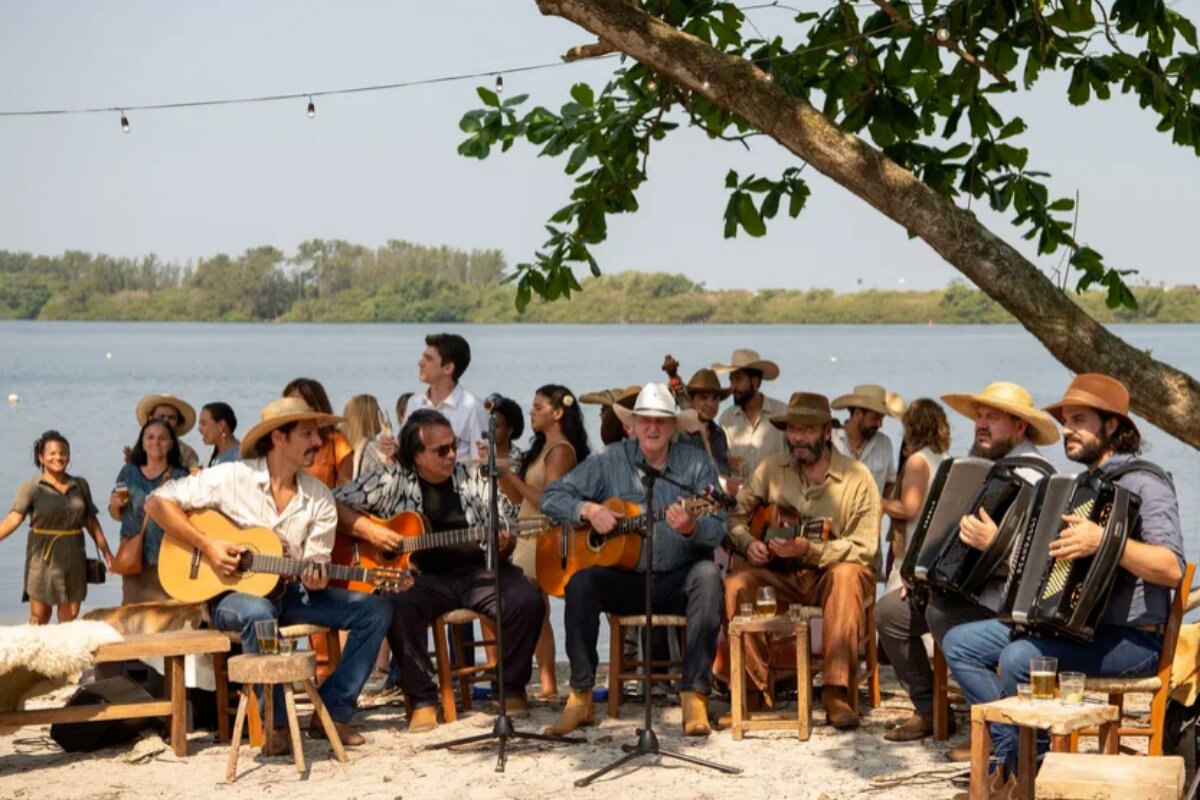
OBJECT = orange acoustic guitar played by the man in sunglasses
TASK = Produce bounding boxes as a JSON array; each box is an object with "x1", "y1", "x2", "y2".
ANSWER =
[{"x1": 331, "y1": 511, "x2": 557, "y2": 591}]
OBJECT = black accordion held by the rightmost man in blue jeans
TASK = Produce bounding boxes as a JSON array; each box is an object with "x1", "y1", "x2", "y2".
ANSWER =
[{"x1": 1000, "y1": 468, "x2": 1137, "y2": 642}]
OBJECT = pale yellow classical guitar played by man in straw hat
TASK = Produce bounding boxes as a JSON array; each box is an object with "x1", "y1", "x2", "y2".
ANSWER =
[{"x1": 158, "y1": 510, "x2": 410, "y2": 602}]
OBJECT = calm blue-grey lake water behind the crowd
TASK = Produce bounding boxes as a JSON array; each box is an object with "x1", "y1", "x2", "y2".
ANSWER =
[{"x1": 0, "y1": 321, "x2": 1200, "y2": 652}]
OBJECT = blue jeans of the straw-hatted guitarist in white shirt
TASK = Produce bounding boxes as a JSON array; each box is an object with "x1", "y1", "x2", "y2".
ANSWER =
[{"x1": 212, "y1": 583, "x2": 391, "y2": 728}]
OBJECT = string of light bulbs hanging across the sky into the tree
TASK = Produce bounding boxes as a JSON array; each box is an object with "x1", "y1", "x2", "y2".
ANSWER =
[{"x1": 0, "y1": 1, "x2": 950, "y2": 133}]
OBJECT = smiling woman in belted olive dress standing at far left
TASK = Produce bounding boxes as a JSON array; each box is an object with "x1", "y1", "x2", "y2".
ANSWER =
[{"x1": 0, "y1": 431, "x2": 113, "y2": 625}]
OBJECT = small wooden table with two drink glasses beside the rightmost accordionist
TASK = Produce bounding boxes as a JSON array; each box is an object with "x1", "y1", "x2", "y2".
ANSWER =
[{"x1": 971, "y1": 697, "x2": 1121, "y2": 800}]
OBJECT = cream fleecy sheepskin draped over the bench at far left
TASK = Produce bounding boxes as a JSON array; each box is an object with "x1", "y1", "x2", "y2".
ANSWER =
[{"x1": 0, "y1": 620, "x2": 121, "y2": 734}]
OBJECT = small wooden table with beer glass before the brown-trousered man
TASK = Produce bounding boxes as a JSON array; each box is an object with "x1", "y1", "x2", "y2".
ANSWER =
[{"x1": 728, "y1": 607, "x2": 821, "y2": 741}]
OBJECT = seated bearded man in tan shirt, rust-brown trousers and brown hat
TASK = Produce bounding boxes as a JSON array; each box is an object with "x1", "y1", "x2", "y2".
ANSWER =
[{"x1": 725, "y1": 392, "x2": 882, "y2": 729}]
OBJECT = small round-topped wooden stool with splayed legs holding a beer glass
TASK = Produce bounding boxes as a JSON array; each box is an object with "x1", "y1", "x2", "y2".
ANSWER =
[{"x1": 226, "y1": 652, "x2": 346, "y2": 783}]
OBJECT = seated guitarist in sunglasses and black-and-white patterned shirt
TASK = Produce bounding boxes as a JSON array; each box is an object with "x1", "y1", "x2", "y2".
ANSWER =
[{"x1": 334, "y1": 409, "x2": 545, "y2": 733}]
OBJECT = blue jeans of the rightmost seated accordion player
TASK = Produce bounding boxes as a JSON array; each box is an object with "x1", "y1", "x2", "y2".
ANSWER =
[{"x1": 942, "y1": 619, "x2": 1163, "y2": 770}]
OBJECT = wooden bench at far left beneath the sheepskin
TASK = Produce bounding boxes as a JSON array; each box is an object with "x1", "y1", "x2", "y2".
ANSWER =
[{"x1": 0, "y1": 630, "x2": 229, "y2": 756}]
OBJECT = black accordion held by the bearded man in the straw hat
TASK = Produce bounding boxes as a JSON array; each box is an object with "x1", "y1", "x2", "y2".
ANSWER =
[{"x1": 901, "y1": 457, "x2": 1051, "y2": 602}]
